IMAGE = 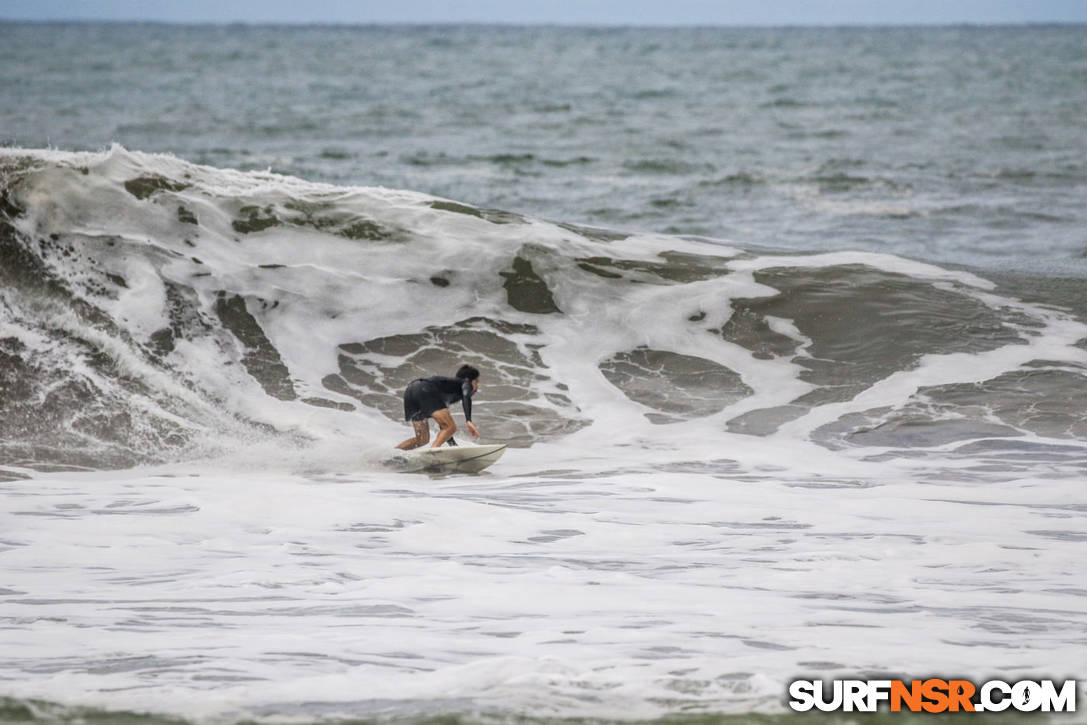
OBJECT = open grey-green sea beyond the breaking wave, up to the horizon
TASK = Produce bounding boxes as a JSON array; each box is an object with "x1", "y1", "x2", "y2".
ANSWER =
[{"x1": 0, "y1": 23, "x2": 1087, "y2": 277}]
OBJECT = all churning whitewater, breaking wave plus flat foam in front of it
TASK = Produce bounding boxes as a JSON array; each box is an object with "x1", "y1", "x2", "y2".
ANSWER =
[{"x1": 0, "y1": 146, "x2": 1087, "y2": 722}]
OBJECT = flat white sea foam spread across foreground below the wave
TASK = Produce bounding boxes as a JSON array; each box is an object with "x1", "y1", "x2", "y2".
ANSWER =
[{"x1": 0, "y1": 458, "x2": 1087, "y2": 716}]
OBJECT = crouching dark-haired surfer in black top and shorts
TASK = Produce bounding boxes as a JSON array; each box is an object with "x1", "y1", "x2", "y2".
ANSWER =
[{"x1": 397, "y1": 365, "x2": 479, "y2": 451}]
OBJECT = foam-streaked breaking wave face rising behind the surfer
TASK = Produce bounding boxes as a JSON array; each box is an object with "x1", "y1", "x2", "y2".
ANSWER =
[{"x1": 0, "y1": 146, "x2": 1087, "y2": 470}]
